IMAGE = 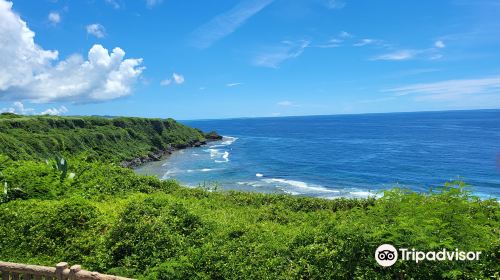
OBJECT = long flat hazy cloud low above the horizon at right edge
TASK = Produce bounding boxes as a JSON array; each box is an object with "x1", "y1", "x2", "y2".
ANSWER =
[{"x1": 385, "y1": 76, "x2": 500, "y2": 101}]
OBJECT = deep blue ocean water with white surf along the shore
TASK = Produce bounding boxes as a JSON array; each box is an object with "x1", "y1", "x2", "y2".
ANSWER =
[{"x1": 137, "y1": 110, "x2": 500, "y2": 198}]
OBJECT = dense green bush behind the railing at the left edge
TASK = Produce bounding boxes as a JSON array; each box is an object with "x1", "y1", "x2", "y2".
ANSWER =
[{"x1": 0, "y1": 198, "x2": 102, "y2": 266}]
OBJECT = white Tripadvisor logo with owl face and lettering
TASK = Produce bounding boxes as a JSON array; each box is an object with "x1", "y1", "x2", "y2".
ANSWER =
[{"x1": 375, "y1": 244, "x2": 481, "y2": 267}]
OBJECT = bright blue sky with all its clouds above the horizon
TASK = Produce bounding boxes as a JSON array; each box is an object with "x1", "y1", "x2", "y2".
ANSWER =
[{"x1": 0, "y1": 0, "x2": 500, "y2": 119}]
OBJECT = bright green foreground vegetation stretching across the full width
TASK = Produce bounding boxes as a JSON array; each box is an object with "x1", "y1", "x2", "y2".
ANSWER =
[{"x1": 0, "y1": 114, "x2": 500, "y2": 279}]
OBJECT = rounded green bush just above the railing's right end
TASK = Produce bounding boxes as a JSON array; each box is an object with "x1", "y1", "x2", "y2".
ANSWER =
[{"x1": 107, "y1": 196, "x2": 203, "y2": 271}]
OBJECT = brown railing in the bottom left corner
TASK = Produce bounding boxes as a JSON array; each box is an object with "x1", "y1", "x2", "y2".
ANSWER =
[{"x1": 0, "y1": 262, "x2": 135, "y2": 280}]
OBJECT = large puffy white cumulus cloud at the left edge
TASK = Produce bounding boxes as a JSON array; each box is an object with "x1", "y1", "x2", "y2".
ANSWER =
[{"x1": 0, "y1": 0, "x2": 144, "y2": 102}]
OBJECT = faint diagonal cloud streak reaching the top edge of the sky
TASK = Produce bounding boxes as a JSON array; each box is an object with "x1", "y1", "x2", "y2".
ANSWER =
[{"x1": 192, "y1": 0, "x2": 274, "y2": 49}]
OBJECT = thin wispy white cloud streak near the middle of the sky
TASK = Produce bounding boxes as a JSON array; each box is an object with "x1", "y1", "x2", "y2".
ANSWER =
[{"x1": 253, "y1": 40, "x2": 310, "y2": 68}]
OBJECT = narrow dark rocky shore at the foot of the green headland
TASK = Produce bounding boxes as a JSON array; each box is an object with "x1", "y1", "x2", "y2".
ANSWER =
[{"x1": 120, "y1": 131, "x2": 222, "y2": 168}]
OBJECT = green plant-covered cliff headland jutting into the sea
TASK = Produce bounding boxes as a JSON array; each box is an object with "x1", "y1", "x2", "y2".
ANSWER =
[{"x1": 0, "y1": 114, "x2": 218, "y2": 163}]
